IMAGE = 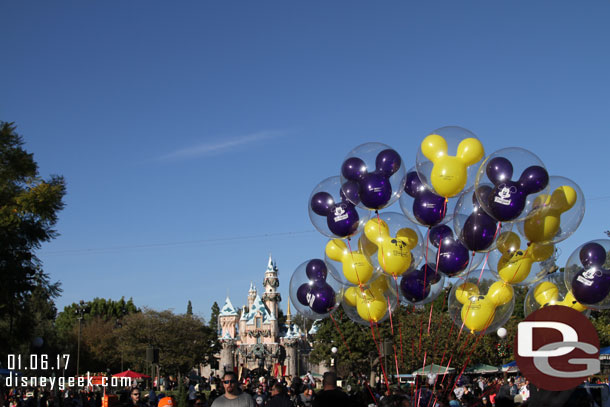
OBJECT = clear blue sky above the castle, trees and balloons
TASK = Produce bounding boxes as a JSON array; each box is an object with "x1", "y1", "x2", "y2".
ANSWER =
[{"x1": 0, "y1": 0, "x2": 610, "y2": 324}]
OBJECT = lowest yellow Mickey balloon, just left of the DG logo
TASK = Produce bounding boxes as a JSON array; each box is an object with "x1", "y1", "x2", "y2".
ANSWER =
[{"x1": 455, "y1": 281, "x2": 514, "y2": 332}]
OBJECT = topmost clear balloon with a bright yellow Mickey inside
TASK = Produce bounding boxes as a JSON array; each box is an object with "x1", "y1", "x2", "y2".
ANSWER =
[{"x1": 416, "y1": 126, "x2": 485, "y2": 198}]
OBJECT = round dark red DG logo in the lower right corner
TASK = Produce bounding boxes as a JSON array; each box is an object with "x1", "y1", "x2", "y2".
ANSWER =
[{"x1": 514, "y1": 305, "x2": 600, "y2": 391}]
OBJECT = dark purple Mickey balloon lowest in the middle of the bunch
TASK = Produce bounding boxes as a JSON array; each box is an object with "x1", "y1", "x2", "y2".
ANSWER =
[{"x1": 399, "y1": 250, "x2": 445, "y2": 306}]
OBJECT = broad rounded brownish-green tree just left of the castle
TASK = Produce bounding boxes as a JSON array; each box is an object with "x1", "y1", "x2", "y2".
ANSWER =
[{"x1": 119, "y1": 310, "x2": 216, "y2": 374}]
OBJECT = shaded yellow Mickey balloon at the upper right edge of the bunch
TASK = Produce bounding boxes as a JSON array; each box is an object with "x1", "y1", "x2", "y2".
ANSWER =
[{"x1": 523, "y1": 185, "x2": 578, "y2": 242}]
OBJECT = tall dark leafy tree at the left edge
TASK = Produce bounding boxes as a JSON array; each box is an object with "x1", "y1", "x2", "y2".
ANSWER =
[{"x1": 0, "y1": 122, "x2": 66, "y2": 359}]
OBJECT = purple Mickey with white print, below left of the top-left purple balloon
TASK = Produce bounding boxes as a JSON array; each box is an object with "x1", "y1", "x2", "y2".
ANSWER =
[{"x1": 310, "y1": 181, "x2": 360, "y2": 237}]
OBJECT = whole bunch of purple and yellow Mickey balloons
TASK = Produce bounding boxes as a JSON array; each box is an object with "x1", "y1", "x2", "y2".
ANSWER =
[{"x1": 291, "y1": 123, "x2": 610, "y2": 333}]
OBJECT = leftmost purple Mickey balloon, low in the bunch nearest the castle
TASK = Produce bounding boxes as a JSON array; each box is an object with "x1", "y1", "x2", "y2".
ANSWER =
[{"x1": 297, "y1": 259, "x2": 336, "y2": 314}]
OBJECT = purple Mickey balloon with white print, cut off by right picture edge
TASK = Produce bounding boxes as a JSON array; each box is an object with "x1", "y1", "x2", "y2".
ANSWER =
[{"x1": 566, "y1": 242, "x2": 610, "y2": 305}]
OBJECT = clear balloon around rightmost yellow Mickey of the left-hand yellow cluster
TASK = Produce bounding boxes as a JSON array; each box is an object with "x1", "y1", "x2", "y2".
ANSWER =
[{"x1": 363, "y1": 212, "x2": 423, "y2": 277}]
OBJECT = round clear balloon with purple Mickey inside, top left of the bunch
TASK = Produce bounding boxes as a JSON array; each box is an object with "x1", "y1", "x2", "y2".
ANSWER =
[{"x1": 341, "y1": 143, "x2": 406, "y2": 210}]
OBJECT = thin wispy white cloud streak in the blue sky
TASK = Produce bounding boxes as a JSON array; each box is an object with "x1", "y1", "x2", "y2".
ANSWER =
[{"x1": 160, "y1": 130, "x2": 286, "y2": 161}]
